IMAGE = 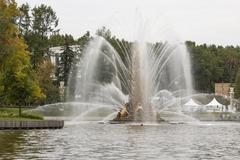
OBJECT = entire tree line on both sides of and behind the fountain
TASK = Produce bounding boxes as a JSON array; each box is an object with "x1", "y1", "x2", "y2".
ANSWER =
[{"x1": 0, "y1": 0, "x2": 240, "y2": 105}]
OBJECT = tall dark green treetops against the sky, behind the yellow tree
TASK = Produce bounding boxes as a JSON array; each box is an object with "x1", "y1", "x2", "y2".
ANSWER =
[{"x1": 17, "y1": 3, "x2": 59, "y2": 68}]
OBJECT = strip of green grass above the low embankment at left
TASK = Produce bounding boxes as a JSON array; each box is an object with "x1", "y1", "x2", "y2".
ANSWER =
[{"x1": 0, "y1": 108, "x2": 43, "y2": 120}]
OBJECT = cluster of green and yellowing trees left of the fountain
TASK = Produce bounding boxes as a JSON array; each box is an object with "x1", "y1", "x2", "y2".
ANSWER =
[{"x1": 0, "y1": 0, "x2": 90, "y2": 106}]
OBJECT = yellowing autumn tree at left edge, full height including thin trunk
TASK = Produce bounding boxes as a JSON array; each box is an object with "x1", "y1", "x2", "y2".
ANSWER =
[{"x1": 0, "y1": 0, "x2": 45, "y2": 115}]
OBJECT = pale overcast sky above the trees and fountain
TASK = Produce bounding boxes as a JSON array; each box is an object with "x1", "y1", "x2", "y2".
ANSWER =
[{"x1": 16, "y1": 0, "x2": 240, "y2": 45}]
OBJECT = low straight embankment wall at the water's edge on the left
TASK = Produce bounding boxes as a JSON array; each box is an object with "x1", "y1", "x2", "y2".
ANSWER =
[{"x1": 0, "y1": 120, "x2": 64, "y2": 130}]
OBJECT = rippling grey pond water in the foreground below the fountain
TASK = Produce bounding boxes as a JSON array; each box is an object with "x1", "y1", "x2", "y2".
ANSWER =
[{"x1": 0, "y1": 122, "x2": 240, "y2": 160}]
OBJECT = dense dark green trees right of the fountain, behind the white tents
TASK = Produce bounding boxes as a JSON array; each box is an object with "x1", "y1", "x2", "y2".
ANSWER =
[{"x1": 186, "y1": 41, "x2": 240, "y2": 92}]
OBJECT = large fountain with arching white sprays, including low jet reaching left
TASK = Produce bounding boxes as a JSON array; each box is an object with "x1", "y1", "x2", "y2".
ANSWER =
[{"x1": 24, "y1": 16, "x2": 195, "y2": 123}]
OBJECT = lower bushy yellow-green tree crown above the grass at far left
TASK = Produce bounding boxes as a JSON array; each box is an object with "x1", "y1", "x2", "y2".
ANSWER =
[{"x1": 0, "y1": 45, "x2": 44, "y2": 106}]
